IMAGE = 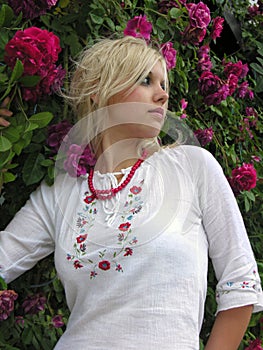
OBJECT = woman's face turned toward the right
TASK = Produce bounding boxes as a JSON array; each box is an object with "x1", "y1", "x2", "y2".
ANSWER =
[{"x1": 105, "y1": 61, "x2": 169, "y2": 139}]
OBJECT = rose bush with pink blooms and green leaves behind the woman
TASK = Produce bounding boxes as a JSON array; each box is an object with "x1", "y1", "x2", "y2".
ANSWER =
[{"x1": 0, "y1": 0, "x2": 263, "y2": 350}]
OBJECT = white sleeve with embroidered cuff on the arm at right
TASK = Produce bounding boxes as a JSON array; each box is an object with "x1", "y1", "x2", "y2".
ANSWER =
[{"x1": 200, "y1": 152, "x2": 263, "y2": 312}]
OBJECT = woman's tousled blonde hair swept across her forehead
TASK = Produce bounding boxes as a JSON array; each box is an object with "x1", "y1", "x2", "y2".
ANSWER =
[{"x1": 67, "y1": 36, "x2": 168, "y2": 155}]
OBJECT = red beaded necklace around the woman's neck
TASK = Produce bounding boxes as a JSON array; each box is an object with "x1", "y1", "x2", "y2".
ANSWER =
[{"x1": 88, "y1": 158, "x2": 143, "y2": 201}]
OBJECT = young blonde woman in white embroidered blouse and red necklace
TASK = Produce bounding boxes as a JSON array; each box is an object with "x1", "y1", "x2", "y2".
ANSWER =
[{"x1": 0, "y1": 37, "x2": 263, "y2": 350}]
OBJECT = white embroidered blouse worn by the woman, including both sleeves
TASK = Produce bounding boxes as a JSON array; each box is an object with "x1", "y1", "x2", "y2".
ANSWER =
[{"x1": 0, "y1": 146, "x2": 263, "y2": 350}]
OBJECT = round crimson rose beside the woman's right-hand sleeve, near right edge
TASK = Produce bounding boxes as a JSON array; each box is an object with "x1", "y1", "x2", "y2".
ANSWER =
[{"x1": 229, "y1": 163, "x2": 257, "y2": 194}]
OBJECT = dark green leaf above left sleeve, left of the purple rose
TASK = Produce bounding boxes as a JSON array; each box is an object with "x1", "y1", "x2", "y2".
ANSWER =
[{"x1": 22, "y1": 153, "x2": 45, "y2": 186}]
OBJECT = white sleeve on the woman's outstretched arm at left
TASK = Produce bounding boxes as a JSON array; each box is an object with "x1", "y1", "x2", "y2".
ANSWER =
[{"x1": 0, "y1": 184, "x2": 55, "y2": 283}]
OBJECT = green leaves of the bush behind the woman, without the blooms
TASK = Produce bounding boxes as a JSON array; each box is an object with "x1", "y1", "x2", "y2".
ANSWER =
[{"x1": 0, "y1": 0, "x2": 263, "y2": 350}]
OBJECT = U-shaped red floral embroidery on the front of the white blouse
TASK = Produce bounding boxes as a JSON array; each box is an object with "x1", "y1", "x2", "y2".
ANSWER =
[{"x1": 66, "y1": 180, "x2": 144, "y2": 279}]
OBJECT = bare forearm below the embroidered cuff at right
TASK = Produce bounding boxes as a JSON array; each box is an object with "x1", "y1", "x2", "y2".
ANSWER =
[{"x1": 205, "y1": 305, "x2": 253, "y2": 350}]
